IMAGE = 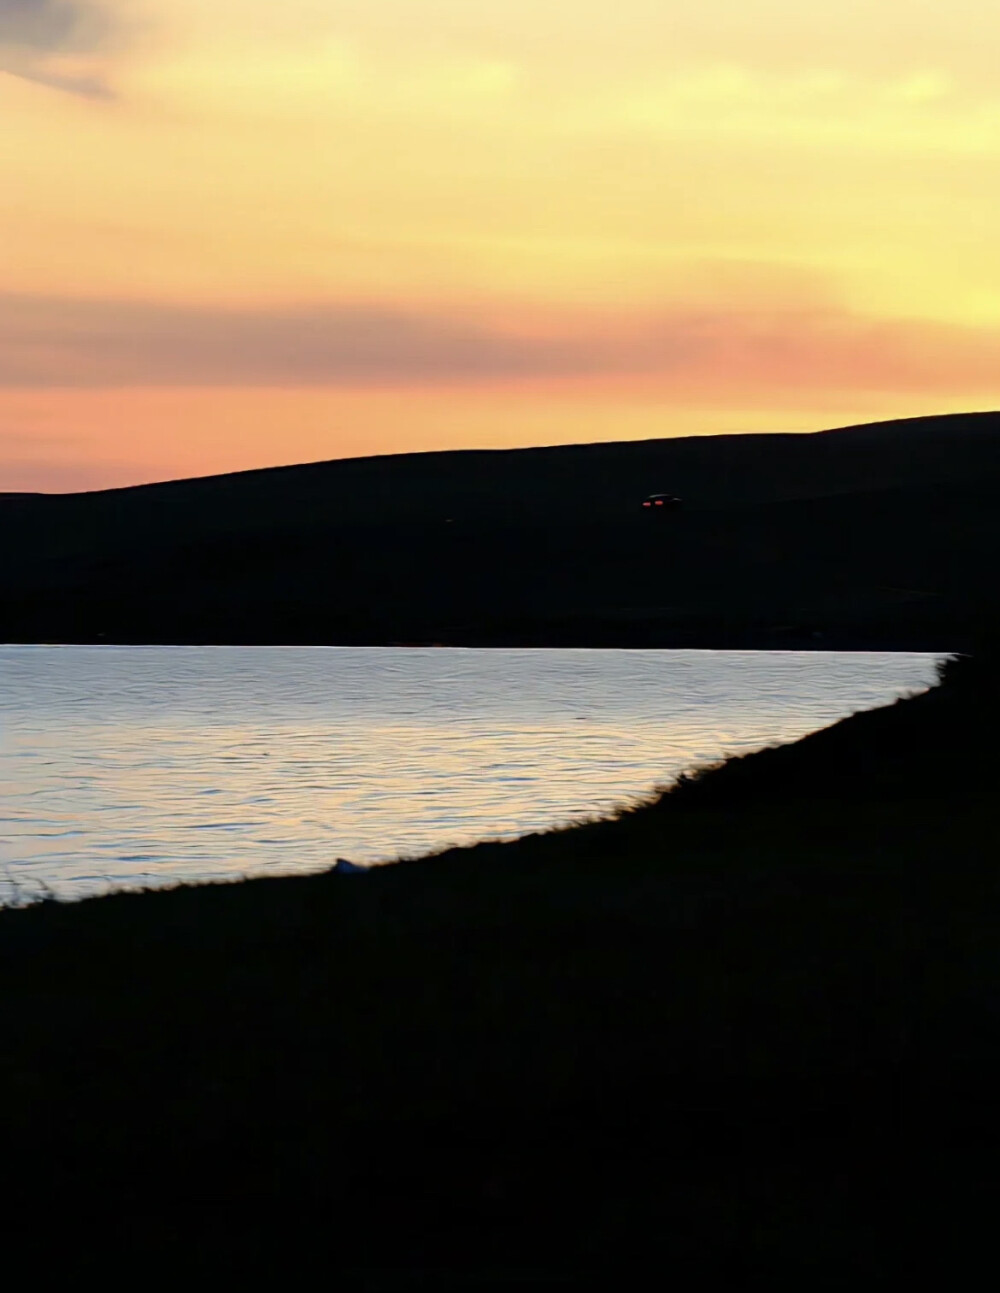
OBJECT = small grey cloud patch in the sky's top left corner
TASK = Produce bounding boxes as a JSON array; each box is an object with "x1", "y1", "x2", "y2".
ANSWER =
[{"x1": 0, "y1": 0, "x2": 115, "y2": 98}]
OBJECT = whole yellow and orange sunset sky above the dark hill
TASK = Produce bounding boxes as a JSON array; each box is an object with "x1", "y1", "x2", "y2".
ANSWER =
[{"x1": 0, "y1": 0, "x2": 1000, "y2": 490}]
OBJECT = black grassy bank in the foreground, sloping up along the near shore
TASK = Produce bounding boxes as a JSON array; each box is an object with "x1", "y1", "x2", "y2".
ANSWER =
[{"x1": 0, "y1": 661, "x2": 1000, "y2": 1290}]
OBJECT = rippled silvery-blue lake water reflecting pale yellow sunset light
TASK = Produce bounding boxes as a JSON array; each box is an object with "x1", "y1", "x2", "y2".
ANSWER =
[{"x1": 0, "y1": 647, "x2": 937, "y2": 900}]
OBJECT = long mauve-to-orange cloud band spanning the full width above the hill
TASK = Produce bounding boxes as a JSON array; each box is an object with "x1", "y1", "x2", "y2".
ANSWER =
[{"x1": 0, "y1": 294, "x2": 1000, "y2": 402}]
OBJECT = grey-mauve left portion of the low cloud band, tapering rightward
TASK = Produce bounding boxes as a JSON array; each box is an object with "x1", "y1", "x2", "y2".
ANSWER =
[{"x1": 0, "y1": 294, "x2": 594, "y2": 387}]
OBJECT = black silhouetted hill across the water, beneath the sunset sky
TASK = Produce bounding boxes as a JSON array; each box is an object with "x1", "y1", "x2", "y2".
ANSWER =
[{"x1": 0, "y1": 414, "x2": 1000, "y2": 648}]
